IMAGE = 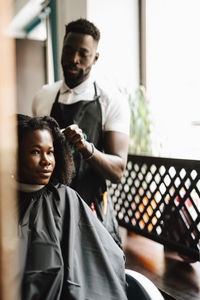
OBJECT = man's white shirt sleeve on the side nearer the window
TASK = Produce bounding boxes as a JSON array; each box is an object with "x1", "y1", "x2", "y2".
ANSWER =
[{"x1": 102, "y1": 90, "x2": 130, "y2": 135}]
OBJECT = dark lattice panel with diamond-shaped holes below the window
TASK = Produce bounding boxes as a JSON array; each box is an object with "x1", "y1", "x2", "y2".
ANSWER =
[{"x1": 109, "y1": 155, "x2": 200, "y2": 260}]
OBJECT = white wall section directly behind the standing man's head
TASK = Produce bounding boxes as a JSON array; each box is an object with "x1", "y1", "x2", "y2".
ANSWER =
[{"x1": 57, "y1": 0, "x2": 139, "y2": 90}]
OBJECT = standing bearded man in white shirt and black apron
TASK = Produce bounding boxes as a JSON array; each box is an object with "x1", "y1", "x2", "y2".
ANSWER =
[{"x1": 33, "y1": 19, "x2": 129, "y2": 243}]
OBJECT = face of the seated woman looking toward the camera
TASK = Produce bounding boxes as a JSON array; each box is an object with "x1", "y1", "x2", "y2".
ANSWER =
[{"x1": 19, "y1": 129, "x2": 55, "y2": 185}]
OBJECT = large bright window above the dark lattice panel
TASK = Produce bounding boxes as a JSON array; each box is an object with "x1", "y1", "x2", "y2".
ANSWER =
[{"x1": 146, "y1": 0, "x2": 200, "y2": 159}]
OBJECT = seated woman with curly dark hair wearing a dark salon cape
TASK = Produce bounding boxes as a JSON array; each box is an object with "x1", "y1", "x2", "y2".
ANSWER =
[{"x1": 18, "y1": 115, "x2": 127, "y2": 300}]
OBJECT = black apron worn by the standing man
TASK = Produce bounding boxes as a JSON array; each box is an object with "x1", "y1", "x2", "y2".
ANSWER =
[{"x1": 50, "y1": 82, "x2": 120, "y2": 243}]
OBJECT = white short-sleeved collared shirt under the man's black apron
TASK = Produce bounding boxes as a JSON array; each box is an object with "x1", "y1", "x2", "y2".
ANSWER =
[{"x1": 32, "y1": 77, "x2": 130, "y2": 134}]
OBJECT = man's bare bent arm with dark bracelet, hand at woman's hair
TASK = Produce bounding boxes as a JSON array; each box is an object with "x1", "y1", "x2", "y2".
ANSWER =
[{"x1": 64, "y1": 124, "x2": 129, "y2": 182}]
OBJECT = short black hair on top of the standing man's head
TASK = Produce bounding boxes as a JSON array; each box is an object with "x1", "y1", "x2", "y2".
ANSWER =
[{"x1": 65, "y1": 18, "x2": 100, "y2": 42}]
